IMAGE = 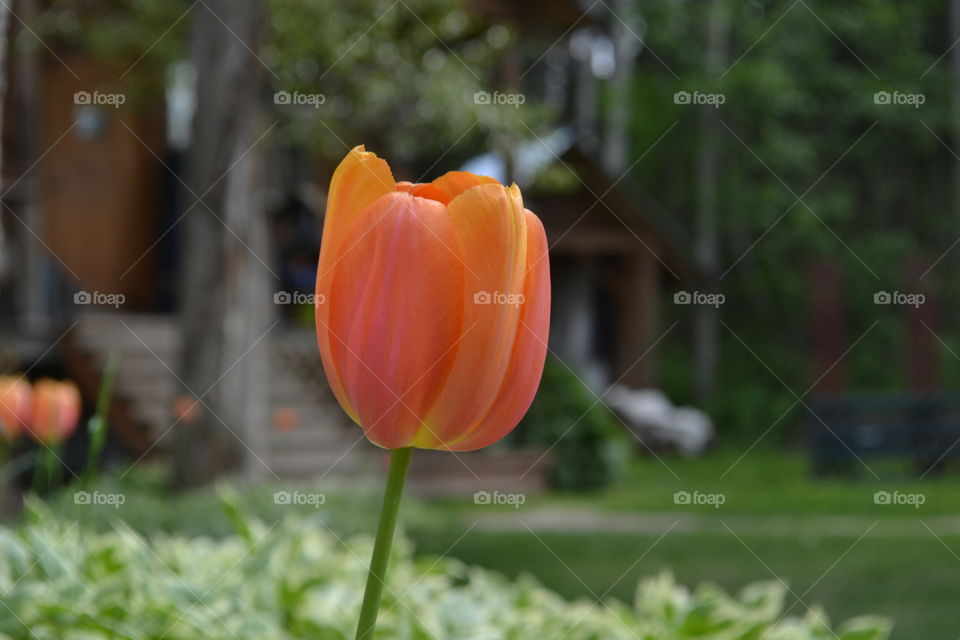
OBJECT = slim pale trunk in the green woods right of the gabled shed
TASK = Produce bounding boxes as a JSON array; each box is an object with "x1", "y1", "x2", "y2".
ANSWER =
[{"x1": 694, "y1": 0, "x2": 730, "y2": 405}]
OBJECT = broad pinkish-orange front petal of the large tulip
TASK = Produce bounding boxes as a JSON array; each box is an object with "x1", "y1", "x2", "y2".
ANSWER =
[{"x1": 318, "y1": 192, "x2": 464, "y2": 449}]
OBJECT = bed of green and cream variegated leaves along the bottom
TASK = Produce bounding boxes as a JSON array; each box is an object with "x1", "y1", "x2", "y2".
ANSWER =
[{"x1": 0, "y1": 511, "x2": 889, "y2": 640}]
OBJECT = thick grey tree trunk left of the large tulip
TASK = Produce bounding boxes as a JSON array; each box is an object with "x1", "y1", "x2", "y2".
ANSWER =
[{"x1": 174, "y1": 0, "x2": 270, "y2": 486}]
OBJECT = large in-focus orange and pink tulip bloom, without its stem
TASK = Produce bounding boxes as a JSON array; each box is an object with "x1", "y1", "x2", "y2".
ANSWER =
[{"x1": 316, "y1": 147, "x2": 550, "y2": 451}]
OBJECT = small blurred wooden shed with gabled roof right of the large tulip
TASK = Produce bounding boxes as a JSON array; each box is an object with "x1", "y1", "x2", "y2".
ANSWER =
[{"x1": 463, "y1": 132, "x2": 696, "y2": 394}]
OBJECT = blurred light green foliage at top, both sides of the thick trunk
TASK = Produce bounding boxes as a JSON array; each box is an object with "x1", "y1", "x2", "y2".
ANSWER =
[{"x1": 37, "y1": 0, "x2": 545, "y2": 169}]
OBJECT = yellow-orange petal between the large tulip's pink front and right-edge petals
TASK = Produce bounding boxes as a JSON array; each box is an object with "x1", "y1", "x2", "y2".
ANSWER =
[{"x1": 415, "y1": 182, "x2": 527, "y2": 449}]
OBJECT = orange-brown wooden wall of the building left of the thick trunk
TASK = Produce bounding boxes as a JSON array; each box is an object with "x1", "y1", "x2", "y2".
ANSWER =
[{"x1": 37, "y1": 58, "x2": 166, "y2": 309}]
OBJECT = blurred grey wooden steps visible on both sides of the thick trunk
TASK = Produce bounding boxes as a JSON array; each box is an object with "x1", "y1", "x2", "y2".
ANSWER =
[{"x1": 68, "y1": 311, "x2": 379, "y2": 479}]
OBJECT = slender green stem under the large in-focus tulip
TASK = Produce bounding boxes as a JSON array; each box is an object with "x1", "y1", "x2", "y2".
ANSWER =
[{"x1": 357, "y1": 447, "x2": 413, "y2": 640}]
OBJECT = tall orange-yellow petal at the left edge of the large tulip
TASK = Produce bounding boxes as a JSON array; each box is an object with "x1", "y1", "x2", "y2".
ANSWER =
[{"x1": 315, "y1": 146, "x2": 396, "y2": 420}]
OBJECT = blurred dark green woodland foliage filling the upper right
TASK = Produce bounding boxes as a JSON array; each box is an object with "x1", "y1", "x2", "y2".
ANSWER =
[{"x1": 632, "y1": 0, "x2": 960, "y2": 440}]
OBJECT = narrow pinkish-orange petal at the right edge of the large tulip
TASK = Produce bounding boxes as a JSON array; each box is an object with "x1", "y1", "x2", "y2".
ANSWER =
[{"x1": 447, "y1": 210, "x2": 550, "y2": 451}]
